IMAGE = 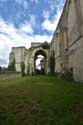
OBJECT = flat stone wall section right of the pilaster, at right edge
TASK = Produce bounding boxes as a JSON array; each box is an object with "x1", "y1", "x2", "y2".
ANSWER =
[{"x1": 68, "y1": 0, "x2": 83, "y2": 81}]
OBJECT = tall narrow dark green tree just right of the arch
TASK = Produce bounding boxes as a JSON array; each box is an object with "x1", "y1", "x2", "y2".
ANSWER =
[{"x1": 49, "y1": 51, "x2": 55, "y2": 74}]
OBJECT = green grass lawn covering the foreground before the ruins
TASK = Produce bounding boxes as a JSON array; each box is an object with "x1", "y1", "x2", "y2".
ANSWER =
[{"x1": 0, "y1": 76, "x2": 83, "y2": 125}]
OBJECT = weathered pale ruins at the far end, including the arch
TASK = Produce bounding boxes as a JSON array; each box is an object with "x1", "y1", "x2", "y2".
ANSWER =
[{"x1": 10, "y1": 43, "x2": 48, "y2": 75}]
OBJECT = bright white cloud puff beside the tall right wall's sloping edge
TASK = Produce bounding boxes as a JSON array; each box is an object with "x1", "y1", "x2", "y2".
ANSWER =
[{"x1": 41, "y1": 10, "x2": 62, "y2": 33}]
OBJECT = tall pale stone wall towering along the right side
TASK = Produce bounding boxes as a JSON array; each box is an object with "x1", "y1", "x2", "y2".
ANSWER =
[{"x1": 50, "y1": 0, "x2": 83, "y2": 81}]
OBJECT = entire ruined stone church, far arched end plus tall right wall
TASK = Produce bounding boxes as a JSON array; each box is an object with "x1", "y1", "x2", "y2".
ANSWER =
[{"x1": 10, "y1": 0, "x2": 83, "y2": 81}]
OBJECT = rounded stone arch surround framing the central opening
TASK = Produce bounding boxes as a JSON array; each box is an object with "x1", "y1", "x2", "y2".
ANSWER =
[{"x1": 29, "y1": 47, "x2": 48, "y2": 75}]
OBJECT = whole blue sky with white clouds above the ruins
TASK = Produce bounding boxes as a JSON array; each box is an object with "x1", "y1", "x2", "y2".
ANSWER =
[{"x1": 0, "y1": 0, "x2": 65, "y2": 66}]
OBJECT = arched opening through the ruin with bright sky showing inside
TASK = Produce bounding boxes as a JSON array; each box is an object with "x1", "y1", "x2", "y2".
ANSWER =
[{"x1": 34, "y1": 50, "x2": 47, "y2": 74}]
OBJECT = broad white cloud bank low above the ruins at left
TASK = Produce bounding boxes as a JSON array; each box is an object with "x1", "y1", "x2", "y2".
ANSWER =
[{"x1": 0, "y1": 18, "x2": 52, "y2": 66}]
